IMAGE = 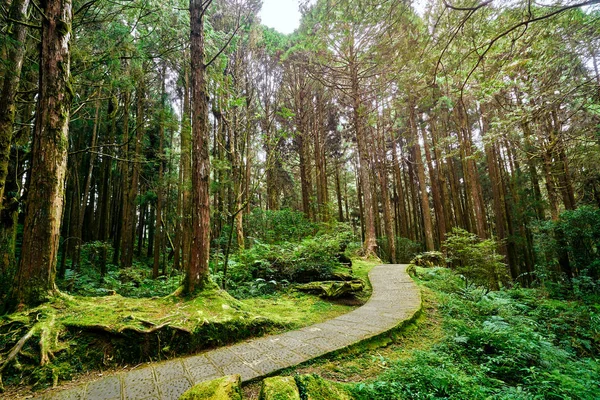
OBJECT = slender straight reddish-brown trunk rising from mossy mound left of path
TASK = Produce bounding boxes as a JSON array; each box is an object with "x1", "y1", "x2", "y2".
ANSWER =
[{"x1": 185, "y1": 0, "x2": 211, "y2": 293}]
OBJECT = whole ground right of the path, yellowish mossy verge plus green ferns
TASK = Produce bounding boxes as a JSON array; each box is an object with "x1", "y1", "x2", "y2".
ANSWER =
[{"x1": 243, "y1": 268, "x2": 600, "y2": 400}]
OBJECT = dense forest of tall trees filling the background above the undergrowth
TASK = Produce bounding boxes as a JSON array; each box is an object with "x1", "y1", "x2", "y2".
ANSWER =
[{"x1": 0, "y1": 0, "x2": 600, "y2": 310}]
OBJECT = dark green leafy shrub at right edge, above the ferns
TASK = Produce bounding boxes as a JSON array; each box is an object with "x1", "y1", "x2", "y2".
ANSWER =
[{"x1": 535, "y1": 206, "x2": 600, "y2": 301}]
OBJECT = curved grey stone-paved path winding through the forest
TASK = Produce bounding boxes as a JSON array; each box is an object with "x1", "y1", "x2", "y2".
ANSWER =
[{"x1": 41, "y1": 264, "x2": 421, "y2": 400}]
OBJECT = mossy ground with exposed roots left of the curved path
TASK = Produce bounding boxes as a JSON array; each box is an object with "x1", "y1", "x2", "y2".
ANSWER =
[{"x1": 0, "y1": 260, "x2": 380, "y2": 395}]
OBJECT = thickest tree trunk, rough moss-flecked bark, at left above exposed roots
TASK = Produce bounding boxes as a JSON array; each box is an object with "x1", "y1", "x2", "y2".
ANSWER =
[{"x1": 7, "y1": 0, "x2": 73, "y2": 309}]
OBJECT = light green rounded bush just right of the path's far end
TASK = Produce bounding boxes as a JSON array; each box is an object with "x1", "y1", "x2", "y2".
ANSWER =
[{"x1": 444, "y1": 228, "x2": 508, "y2": 290}]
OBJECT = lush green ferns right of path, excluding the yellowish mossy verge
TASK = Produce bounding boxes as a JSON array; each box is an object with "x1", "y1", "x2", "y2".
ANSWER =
[{"x1": 353, "y1": 268, "x2": 600, "y2": 400}]
